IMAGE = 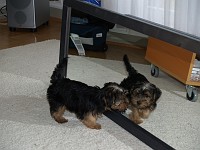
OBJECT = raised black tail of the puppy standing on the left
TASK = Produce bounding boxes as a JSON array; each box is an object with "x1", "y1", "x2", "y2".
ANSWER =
[{"x1": 50, "y1": 58, "x2": 67, "y2": 83}]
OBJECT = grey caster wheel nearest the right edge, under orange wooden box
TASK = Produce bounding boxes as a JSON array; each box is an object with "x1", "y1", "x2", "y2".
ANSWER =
[{"x1": 186, "y1": 85, "x2": 198, "y2": 102}]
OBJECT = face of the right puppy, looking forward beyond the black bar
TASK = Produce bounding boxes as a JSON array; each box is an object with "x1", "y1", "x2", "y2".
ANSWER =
[{"x1": 130, "y1": 82, "x2": 162, "y2": 112}]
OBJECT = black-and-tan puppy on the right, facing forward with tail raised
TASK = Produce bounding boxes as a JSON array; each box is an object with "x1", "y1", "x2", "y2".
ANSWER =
[{"x1": 120, "y1": 55, "x2": 162, "y2": 124}]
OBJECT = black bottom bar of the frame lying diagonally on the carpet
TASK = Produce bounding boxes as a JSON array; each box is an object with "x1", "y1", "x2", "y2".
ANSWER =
[{"x1": 104, "y1": 111, "x2": 174, "y2": 150}]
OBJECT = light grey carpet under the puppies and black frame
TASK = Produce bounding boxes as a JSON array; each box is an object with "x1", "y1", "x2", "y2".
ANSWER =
[{"x1": 0, "y1": 40, "x2": 200, "y2": 150}]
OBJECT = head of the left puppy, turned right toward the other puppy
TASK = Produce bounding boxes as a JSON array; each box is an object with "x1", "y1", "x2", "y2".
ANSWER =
[{"x1": 103, "y1": 82, "x2": 129, "y2": 112}]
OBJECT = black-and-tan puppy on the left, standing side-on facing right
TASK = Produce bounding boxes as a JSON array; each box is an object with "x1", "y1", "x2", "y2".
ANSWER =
[{"x1": 47, "y1": 59, "x2": 128, "y2": 129}]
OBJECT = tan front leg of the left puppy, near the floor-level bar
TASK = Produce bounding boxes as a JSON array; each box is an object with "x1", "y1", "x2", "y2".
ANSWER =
[{"x1": 81, "y1": 113, "x2": 101, "y2": 129}]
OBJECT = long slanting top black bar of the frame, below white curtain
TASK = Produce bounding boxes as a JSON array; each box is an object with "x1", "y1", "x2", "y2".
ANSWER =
[{"x1": 64, "y1": 0, "x2": 200, "y2": 54}]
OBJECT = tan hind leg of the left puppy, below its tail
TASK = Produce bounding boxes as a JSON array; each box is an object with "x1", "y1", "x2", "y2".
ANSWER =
[{"x1": 50, "y1": 106, "x2": 68, "y2": 123}]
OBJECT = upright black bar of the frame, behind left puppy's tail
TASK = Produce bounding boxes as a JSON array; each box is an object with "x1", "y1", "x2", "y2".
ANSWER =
[{"x1": 59, "y1": 6, "x2": 71, "y2": 77}]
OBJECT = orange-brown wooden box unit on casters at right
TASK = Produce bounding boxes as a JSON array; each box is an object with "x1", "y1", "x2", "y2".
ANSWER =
[{"x1": 145, "y1": 37, "x2": 200, "y2": 101}]
